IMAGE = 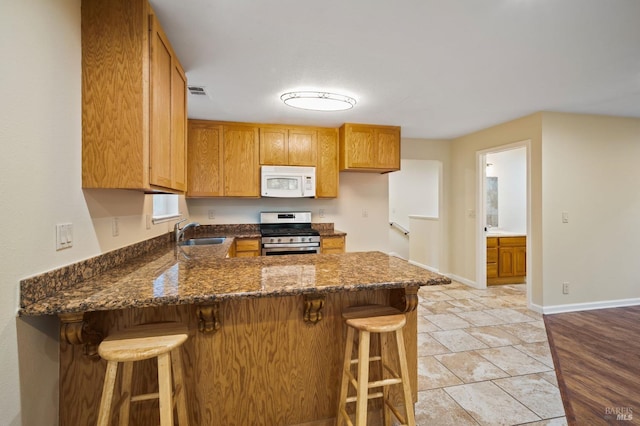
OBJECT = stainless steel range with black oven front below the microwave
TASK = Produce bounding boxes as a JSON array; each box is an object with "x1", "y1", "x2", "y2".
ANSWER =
[{"x1": 260, "y1": 212, "x2": 320, "y2": 256}]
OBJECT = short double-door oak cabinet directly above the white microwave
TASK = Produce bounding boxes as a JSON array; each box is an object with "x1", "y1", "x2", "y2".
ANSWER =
[{"x1": 260, "y1": 126, "x2": 317, "y2": 166}]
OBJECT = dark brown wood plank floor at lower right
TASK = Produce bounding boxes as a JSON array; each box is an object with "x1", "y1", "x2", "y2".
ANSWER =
[{"x1": 544, "y1": 306, "x2": 640, "y2": 425}]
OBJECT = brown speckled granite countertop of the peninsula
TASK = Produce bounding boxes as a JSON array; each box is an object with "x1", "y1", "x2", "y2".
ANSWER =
[{"x1": 19, "y1": 243, "x2": 450, "y2": 316}]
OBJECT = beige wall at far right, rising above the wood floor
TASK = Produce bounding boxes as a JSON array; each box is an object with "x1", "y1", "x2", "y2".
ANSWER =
[{"x1": 543, "y1": 113, "x2": 640, "y2": 310}]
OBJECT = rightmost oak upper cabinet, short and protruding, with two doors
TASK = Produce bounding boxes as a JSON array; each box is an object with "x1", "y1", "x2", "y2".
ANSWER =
[{"x1": 340, "y1": 123, "x2": 400, "y2": 173}]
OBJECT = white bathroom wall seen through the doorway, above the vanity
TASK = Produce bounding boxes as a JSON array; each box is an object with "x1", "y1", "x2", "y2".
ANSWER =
[{"x1": 487, "y1": 148, "x2": 527, "y2": 234}]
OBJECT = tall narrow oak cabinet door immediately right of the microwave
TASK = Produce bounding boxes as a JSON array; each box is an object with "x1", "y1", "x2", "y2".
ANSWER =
[{"x1": 316, "y1": 129, "x2": 340, "y2": 198}]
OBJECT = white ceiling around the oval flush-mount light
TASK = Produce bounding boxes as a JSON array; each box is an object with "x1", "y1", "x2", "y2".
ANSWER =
[{"x1": 151, "y1": 0, "x2": 640, "y2": 138}]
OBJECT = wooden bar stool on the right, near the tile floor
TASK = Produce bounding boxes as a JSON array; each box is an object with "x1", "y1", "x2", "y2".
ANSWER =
[{"x1": 337, "y1": 305, "x2": 416, "y2": 426}]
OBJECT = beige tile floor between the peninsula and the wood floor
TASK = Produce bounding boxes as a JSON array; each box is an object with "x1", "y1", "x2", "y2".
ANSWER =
[{"x1": 416, "y1": 282, "x2": 567, "y2": 426}]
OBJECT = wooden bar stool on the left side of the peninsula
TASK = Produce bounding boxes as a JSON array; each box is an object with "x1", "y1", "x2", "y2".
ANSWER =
[{"x1": 98, "y1": 323, "x2": 189, "y2": 426}]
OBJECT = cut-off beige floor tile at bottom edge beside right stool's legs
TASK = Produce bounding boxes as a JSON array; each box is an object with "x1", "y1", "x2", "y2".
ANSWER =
[{"x1": 415, "y1": 389, "x2": 478, "y2": 426}]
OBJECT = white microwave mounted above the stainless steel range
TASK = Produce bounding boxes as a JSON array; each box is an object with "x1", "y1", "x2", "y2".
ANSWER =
[{"x1": 260, "y1": 166, "x2": 316, "y2": 198}]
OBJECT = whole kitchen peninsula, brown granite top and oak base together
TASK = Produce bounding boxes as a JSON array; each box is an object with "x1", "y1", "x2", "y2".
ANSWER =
[{"x1": 20, "y1": 233, "x2": 449, "y2": 425}]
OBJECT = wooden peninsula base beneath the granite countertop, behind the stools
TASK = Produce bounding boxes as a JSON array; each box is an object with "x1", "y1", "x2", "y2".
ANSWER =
[{"x1": 60, "y1": 286, "x2": 417, "y2": 426}]
